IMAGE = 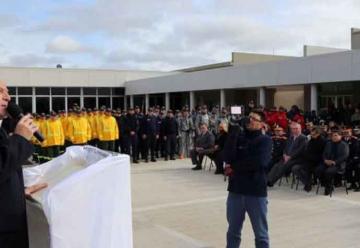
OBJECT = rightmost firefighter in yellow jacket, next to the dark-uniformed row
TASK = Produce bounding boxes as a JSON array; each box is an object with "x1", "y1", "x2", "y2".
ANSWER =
[{"x1": 98, "y1": 109, "x2": 119, "y2": 151}]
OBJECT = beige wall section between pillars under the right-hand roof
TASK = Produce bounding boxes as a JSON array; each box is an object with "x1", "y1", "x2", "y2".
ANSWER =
[{"x1": 274, "y1": 86, "x2": 304, "y2": 109}]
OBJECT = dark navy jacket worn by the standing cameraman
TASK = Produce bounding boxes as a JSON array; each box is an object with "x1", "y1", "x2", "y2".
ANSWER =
[{"x1": 224, "y1": 130, "x2": 272, "y2": 197}]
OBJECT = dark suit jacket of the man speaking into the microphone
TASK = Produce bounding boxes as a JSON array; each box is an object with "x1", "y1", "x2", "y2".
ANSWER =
[{"x1": 0, "y1": 128, "x2": 33, "y2": 232}]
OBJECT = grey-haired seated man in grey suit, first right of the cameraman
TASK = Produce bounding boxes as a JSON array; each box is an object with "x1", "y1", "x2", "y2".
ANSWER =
[{"x1": 268, "y1": 122, "x2": 307, "y2": 187}]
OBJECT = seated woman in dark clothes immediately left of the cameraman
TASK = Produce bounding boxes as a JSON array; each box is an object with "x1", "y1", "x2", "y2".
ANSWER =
[{"x1": 208, "y1": 122, "x2": 228, "y2": 174}]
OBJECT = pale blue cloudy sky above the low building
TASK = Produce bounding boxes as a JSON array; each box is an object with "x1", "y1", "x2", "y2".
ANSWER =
[{"x1": 0, "y1": 0, "x2": 360, "y2": 71}]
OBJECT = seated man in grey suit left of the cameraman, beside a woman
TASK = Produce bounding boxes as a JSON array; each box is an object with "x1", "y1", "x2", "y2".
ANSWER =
[{"x1": 190, "y1": 123, "x2": 215, "y2": 170}]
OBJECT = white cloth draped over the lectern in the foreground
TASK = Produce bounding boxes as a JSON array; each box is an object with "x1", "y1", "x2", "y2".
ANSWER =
[{"x1": 24, "y1": 146, "x2": 133, "y2": 248}]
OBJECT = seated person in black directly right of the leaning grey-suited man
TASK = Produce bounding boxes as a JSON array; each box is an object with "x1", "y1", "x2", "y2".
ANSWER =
[{"x1": 292, "y1": 127, "x2": 327, "y2": 192}]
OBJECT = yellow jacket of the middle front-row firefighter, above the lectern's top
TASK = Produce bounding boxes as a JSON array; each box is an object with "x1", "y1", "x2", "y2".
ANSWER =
[{"x1": 67, "y1": 116, "x2": 91, "y2": 145}]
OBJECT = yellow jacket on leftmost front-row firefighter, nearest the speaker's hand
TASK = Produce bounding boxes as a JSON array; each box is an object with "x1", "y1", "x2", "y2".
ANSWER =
[{"x1": 45, "y1": 119, "x2": 65, "y2": 146}]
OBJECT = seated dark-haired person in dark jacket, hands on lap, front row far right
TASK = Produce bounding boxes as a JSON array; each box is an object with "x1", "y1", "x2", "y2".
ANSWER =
[{"x1": 315, "y1": 129, "x2": 349, "y2": 195}]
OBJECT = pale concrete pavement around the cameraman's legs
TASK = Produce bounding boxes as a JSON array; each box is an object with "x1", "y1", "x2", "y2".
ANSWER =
[{"x1": 132, "y1": 160, "x2": 360, "y2": 248}]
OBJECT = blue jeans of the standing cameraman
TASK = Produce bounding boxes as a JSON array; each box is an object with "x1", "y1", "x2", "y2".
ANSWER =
[{"x1": 226, "y1": 192, "x2": 269, "y2": 248}]
